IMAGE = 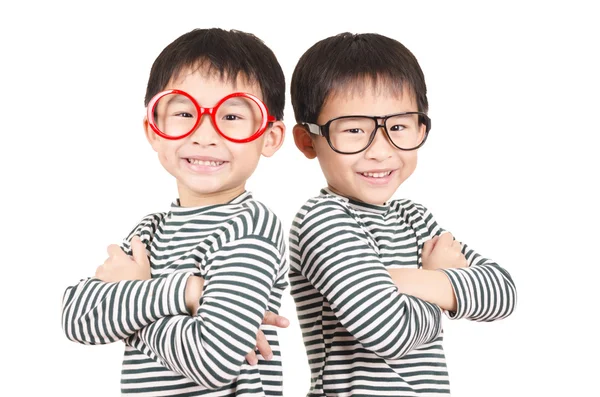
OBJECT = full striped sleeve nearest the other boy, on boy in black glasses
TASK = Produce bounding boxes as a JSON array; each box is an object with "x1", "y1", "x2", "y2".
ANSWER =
[{"x1": 290, "y1": 202, "x2": 442, "y2": 359}]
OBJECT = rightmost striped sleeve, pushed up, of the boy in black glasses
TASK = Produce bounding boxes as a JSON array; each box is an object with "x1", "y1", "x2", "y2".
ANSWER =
[{"x1": 418, "y1": 205, "x2": 517, "y2": 321}]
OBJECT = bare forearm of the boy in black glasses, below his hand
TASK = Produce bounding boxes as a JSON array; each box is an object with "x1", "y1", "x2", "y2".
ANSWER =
[{"x1": 387, "y1": 268, "x2": 456, "y2": 312}]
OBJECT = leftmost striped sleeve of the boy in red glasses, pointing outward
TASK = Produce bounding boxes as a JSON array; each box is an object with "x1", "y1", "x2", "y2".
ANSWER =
[{"x1": 62, "y1": 215, "x2": 191, "y2": 345}]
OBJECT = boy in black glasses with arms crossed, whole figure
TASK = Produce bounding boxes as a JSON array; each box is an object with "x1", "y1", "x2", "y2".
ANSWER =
[{"x1": 290, "y1": 33, "x2": 516, "y2": 397}]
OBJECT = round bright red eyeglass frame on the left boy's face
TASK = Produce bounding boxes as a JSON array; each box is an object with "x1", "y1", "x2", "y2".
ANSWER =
[{"x1": 146, "y1": 89, "x2": 277, "y2": 143}]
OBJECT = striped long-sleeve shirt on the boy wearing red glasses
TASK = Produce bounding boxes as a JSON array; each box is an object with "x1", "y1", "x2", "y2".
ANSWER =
[{"x1": 62, "y1": 192, "x2": 289, "y2": 396}]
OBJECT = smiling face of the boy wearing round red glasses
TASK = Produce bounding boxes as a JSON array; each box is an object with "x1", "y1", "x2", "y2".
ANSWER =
[{"x1": 144, "y1": 68, "x2": 285, "y2": 207}]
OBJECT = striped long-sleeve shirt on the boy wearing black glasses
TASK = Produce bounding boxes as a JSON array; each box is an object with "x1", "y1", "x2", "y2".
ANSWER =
[{"x1": 290, "y1": 189, "x2": 516, "y2": 397}]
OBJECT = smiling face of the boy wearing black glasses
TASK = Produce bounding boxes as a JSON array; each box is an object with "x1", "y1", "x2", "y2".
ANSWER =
[{"x1": 294, "y1": 85, "x2": 426, "y2": 205}]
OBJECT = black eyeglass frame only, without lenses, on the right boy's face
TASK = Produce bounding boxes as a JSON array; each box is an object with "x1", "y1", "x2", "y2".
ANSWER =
[{"x1": 299, "y1": 112, "x2": 431, "y2": 154}]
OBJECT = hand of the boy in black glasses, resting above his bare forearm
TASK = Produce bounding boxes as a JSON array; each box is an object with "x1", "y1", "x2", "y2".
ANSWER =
[{"x1": 421, "y1": 232, "x2": 467, "y2": 270}]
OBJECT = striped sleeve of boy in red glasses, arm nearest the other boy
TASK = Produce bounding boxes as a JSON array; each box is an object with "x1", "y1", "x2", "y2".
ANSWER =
[{"x1": 127, "y1": 235, "x2": 284, "y2": 389}]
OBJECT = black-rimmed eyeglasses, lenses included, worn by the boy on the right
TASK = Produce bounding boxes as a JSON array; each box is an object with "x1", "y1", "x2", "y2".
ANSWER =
[{"x1": 300, "y1": 112, "x2": 431, "y2": 154}]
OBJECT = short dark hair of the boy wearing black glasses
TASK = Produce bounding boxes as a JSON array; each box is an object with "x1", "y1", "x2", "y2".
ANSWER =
[{"x1": 291, "y1": 32, "x2": 429, "y2": 123}]
